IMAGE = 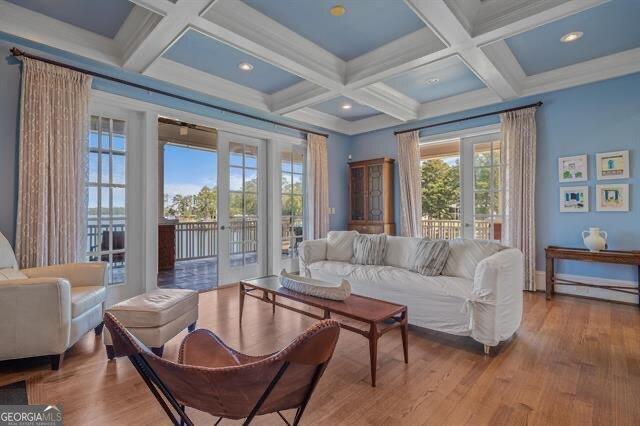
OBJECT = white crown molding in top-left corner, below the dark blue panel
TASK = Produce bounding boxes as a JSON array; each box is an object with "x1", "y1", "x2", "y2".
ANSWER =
[{"x1": 0, "y1": 0, "x2": 121, "y2": 66}]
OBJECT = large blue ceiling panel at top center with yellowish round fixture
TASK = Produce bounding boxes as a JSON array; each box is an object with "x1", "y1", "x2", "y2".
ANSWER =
[{"x1": 240, "y1": 0, "x2": 424, "y2": 61}]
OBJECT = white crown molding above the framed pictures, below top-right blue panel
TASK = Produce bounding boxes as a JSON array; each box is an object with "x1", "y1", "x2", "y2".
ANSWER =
[{"x1": 522, "y1": 48, "x2": 640, "y2": 96}]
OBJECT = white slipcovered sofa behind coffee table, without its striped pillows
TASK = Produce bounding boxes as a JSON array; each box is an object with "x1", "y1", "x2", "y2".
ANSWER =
[{"x1": 299, "y1": 231, "x2": 524, "y2": 351}]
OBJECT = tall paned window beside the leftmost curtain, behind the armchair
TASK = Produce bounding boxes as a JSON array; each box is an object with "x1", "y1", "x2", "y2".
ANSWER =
[{"x1": 86, "y1": 115, "x2": 127, "y2": 284}]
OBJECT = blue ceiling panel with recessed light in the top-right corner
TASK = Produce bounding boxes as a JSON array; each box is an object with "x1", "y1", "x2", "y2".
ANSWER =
[{"x1": 506, "y1": 0, "x2": 640, "y2": 75}]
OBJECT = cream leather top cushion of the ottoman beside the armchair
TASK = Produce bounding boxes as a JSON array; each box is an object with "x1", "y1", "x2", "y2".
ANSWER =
[{"x1": 108, "y1": 289, "x2": 198, "y2": 327}]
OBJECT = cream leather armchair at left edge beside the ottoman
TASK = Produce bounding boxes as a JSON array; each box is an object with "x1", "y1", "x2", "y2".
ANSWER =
[{"x1": 0, "y1": 233, "x2": 106, "y2": 370}]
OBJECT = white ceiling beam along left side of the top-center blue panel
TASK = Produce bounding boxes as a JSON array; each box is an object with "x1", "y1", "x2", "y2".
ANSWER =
[{"x1": 199, "y1": 0, "x2": 346, "y2": 90}]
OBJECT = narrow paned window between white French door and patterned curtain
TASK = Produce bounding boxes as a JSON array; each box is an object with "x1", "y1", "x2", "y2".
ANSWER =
[{"x1": 280, "y1": 148, "x2": 304, "y2": 259}]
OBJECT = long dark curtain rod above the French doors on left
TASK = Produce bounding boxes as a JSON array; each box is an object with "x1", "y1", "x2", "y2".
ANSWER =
[{"x1": 11, "y1": 47, "x2": 329, "y2": 138}]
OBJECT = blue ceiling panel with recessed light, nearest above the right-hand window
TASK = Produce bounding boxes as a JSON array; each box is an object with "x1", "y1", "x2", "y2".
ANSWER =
[{"x1": 384, "y1": 57, "x2": 485, "y2": 103}]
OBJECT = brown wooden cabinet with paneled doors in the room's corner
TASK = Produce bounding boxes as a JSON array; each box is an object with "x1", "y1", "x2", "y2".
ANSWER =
[{"x1": 348, "y1": 158, "x2": 396, "y2": 235}]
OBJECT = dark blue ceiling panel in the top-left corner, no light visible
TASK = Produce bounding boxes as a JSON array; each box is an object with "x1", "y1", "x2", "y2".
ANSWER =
[{"x1": 8, "y1": 0, "x2": 133, "y2": 38}]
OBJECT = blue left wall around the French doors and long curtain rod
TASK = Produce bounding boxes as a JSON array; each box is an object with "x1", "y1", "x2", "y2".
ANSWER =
[{"x1": 0, "y1": 32, "x2": 349, "y2": 241}]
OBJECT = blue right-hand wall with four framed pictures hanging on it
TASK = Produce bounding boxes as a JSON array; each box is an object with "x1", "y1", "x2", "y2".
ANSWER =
[{"x1": 350, "y1": 74, "x2": 640, "y2": 280}]
